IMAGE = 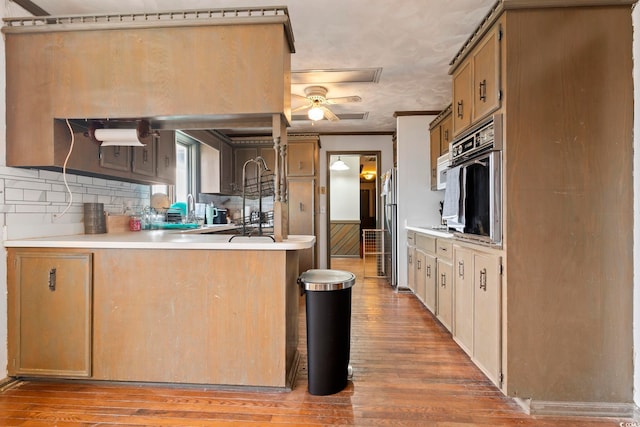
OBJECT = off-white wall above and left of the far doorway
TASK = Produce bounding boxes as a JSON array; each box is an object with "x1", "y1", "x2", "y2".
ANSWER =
[{"x1": 317, "y1": 135, "x2": 393, "y2": 268}]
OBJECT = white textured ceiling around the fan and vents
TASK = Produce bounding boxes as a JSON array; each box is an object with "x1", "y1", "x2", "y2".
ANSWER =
[{"x1": 7, "y1": 0, "x2": 495, "y2": 133}]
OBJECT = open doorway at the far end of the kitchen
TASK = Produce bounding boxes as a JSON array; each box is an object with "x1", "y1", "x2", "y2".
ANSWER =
[{"x1": 327, "y1": 151, "x2": 381, "y2": 268}]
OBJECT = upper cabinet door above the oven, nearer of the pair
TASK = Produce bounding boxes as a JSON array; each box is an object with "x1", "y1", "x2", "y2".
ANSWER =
[{"x1": 472, "y1": 27, "x2": 500, "y2": 122}]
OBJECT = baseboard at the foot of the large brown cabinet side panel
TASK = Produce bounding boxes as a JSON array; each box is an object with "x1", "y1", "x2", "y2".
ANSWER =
[{"x1": 521, "y1": 400, "x2": 638, "y2": 419}]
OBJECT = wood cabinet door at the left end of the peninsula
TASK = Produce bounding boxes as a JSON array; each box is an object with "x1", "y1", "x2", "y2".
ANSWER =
[{"x1": 9, "y1": 251, "x2": 92, "y2": 377}]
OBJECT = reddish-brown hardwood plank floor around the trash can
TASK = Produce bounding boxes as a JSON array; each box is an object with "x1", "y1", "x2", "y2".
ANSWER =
[{"x1": 0, "y1": 258, "x2": 632, "y2": 427}]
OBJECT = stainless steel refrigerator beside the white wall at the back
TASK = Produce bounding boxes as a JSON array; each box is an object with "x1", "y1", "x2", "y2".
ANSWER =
[{"x1": 380, "y1": 168, "x2": 398, "y2": 289}]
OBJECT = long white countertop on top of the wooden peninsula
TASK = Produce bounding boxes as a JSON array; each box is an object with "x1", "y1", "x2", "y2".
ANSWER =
[{"x1": 4, "y1": 230, "x2": 315, "y2": 251}]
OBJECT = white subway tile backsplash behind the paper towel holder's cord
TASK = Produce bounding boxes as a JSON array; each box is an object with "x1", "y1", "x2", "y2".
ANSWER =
[{"x1": 0, "y1": 167, "x2": 151, "y2": 239}]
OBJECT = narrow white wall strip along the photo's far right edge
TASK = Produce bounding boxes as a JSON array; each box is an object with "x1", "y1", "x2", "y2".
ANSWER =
[{"x1": 633, "y1": 3, "x2": 640, "y2": 406}]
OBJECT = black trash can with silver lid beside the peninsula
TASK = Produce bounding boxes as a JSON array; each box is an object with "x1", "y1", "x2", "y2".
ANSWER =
[{"x1": 298, "y1": 269, "x2": 356, "y2": 396}]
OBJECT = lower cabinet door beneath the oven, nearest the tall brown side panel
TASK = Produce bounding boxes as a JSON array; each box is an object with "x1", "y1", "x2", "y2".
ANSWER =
[{"x1": 473, "y1": 254, "x2": 502, "y2": 384}]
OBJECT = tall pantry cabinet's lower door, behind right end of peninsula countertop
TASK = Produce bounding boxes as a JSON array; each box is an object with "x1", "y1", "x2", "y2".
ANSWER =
[{"x1": 287, "y1": 179, "x2": 316, "y2": 272}]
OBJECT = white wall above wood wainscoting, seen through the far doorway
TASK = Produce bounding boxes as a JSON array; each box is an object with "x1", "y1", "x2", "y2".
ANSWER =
[{"x1": 329, "y1": 155, "x2": 360, "y2": 221}]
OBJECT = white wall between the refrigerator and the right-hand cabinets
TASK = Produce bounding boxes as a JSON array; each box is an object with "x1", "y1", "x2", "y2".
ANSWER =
[{"x1": 397, "y1": 116, "x2": 444, "y2": 288}]
